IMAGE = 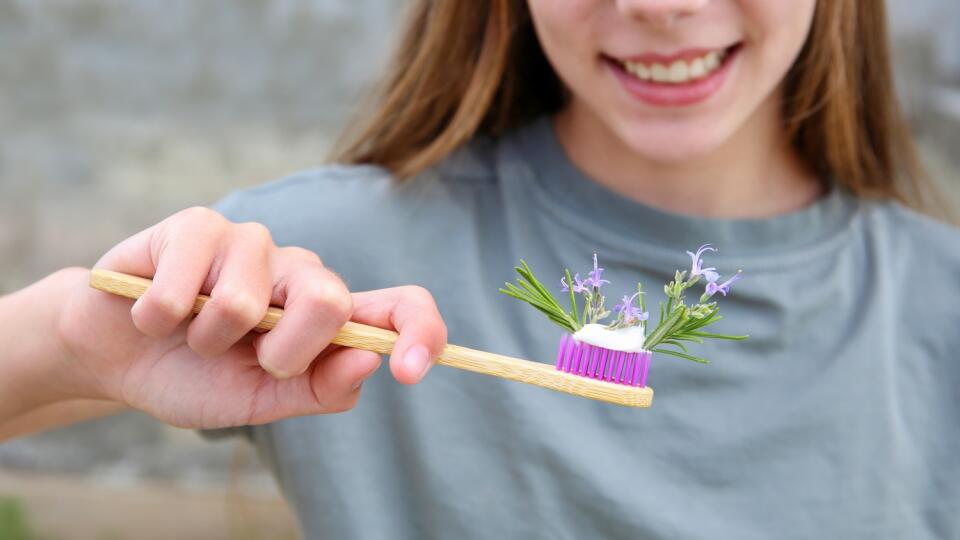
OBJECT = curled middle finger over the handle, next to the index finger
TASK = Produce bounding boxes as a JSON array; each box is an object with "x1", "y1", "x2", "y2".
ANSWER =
[{"x1": 257, "y1": 262, "x2": 353, "y2": 378}]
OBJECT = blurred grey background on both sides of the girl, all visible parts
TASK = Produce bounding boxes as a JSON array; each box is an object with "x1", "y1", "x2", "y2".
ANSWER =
[{"x1": 0, "y1": 0, "x2": 960, "y2": 540}]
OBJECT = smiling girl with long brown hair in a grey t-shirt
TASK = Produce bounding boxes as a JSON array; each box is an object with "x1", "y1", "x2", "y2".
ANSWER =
[{"x1": 5, "y1": 0, "x2": 960, "y2": 539}]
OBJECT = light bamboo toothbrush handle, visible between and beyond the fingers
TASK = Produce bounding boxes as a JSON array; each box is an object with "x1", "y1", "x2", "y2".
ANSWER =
[{"x1": 90, "y1": 269, "x2": 653, "y2": 407}]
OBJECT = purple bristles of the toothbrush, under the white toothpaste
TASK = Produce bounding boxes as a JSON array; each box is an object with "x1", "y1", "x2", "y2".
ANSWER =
[{"x1": 557, "y1": 334, "x2": 652, "y2": 387}]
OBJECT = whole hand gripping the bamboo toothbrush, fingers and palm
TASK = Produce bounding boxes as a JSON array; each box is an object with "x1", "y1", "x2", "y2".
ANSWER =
[{"x1": 58, "y1": 208, "x2": 446, "y2": 428}]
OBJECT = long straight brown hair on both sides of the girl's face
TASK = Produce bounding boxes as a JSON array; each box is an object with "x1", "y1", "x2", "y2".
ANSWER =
[{"x1": 336, "y1": 0, "x2": 936, "y2": 215}]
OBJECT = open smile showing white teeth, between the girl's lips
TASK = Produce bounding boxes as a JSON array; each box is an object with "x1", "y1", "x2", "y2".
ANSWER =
[{"x1": 608, "y1": 43, "x2": 740, "y2": 85}]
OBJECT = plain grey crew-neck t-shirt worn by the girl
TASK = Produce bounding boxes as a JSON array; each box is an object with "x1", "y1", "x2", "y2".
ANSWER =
[{"x1": 210, "y1": 119, "x2": 960, "y2": 540}]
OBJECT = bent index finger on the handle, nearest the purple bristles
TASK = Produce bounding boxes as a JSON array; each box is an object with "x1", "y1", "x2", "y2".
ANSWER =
[{"x1": 351, "y1": 286, "x2": 447, "y2": 384}]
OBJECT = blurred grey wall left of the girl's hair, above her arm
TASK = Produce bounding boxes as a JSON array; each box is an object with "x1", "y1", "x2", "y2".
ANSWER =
[{"x1": 0, "y1": 0, "x2": 398, "y2": 291}]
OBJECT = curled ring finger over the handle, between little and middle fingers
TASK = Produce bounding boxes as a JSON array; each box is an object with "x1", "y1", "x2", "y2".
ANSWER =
[{"x1": 185, "y1": 223, "x2": 273, "y2": 358}]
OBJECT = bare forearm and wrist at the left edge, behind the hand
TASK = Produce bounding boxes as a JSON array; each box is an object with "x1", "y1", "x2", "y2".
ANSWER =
[{"x1": 0, "y1": 269, "x2": 114, "y2": 438}]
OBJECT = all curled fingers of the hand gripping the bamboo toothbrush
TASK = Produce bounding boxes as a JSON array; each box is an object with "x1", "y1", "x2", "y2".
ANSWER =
[{"x1": 92, "y1": 208, "x2": 447, "y2": 396}]
